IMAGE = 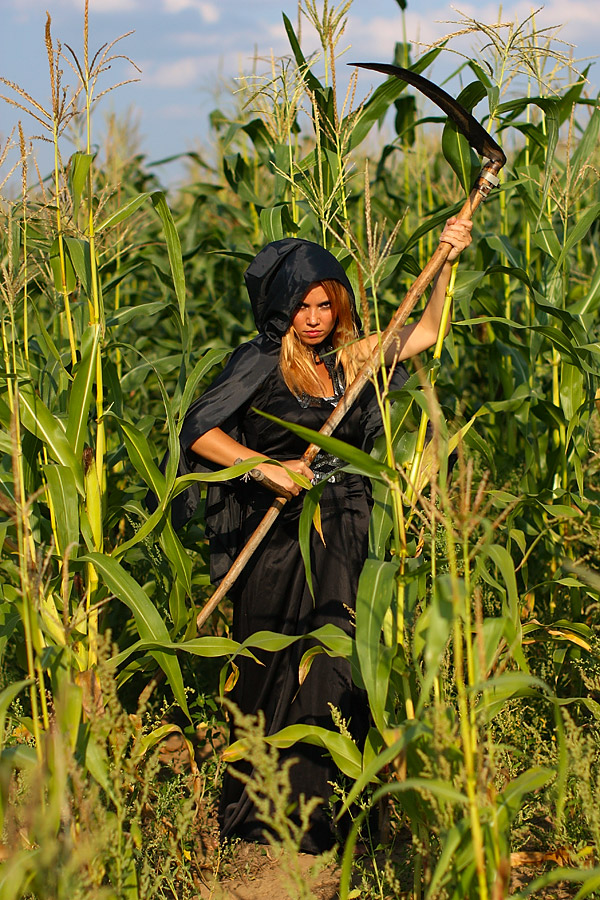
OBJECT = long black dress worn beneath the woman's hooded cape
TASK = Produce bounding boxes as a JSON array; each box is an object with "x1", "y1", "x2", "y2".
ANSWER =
[{"x1": 220, "y1": 366, "x2": 370, "y2": 853}]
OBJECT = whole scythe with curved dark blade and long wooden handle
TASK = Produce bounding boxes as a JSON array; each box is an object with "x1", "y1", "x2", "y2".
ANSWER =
[{"x1": 196, "y1": 63, "x2": 506, "y2": 629}]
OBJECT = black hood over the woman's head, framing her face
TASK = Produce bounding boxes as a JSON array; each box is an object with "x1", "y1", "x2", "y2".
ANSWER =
[{"x1": 244, "y1": 238, "x2": 360, "y2": 342}]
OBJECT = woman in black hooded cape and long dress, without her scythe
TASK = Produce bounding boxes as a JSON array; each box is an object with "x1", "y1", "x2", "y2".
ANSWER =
[{"x1": 174, "y1": 219, "x2": 471, "y2": 853}]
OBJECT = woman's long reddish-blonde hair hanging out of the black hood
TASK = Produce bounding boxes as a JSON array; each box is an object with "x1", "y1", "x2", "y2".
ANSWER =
[{"x1": 279, "y1": 278, "x2": 362, "y2": 397}]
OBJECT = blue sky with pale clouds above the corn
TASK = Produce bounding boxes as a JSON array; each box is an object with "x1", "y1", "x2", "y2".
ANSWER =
[{"x1": 0, "y1": 0, "x2": 600, "y2": 183}]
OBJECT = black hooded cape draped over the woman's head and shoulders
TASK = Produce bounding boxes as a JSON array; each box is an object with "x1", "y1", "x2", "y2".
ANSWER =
[{"x1": 171, "y1": 238, "x2": 408, "y2": 584}]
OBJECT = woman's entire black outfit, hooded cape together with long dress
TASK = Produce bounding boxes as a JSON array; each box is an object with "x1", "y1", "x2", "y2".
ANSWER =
[{"x1": 172, "y1": 238, "x2": 407, "y2": 853}]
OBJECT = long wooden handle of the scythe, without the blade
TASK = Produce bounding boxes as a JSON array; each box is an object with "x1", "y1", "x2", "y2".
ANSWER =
[{"x1": 196, "y1": 161, "x2": 502, "y2": 629}]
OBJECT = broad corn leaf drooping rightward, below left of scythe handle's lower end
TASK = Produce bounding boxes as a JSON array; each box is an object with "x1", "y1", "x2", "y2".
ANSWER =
[{"x1": 81, "y1": 553, "x2": 190, "y2": 718}]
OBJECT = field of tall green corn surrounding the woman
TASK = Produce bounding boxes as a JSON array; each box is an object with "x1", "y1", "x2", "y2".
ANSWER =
[{"x1": 0, "y1": 0, "x2": 600, "y2": 900}]
